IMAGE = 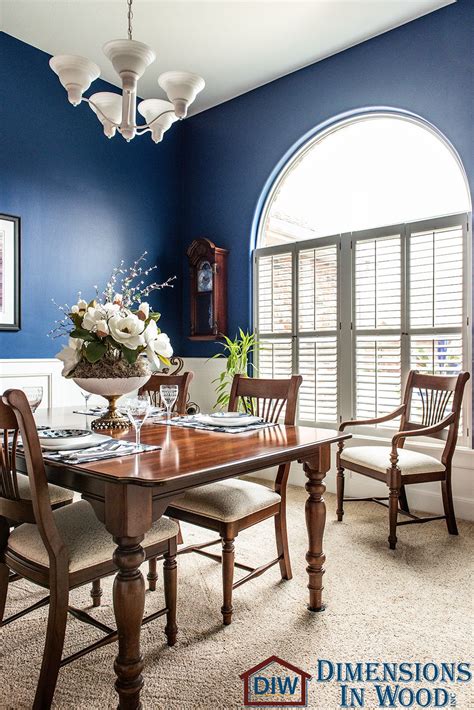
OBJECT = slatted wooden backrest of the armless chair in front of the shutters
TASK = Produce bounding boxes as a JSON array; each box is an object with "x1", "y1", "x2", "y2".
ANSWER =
[{"x1": 229, "y1": 375, "x2": 303, "y2": 425}]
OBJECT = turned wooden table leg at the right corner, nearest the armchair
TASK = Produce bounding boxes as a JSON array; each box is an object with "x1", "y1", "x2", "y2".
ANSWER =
[{"x1": 303, "y1": 444, "x2": 331, "y2": 611}]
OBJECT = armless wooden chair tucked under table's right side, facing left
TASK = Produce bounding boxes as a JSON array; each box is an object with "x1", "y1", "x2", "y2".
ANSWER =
[{"x1": 167, "y1": 375, "x2": 303, "y2": 625}]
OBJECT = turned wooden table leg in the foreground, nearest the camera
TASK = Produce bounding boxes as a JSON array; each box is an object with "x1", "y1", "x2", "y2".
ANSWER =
[{"x1": 113, "y1": 535, "x2": 145, "y2": 710}]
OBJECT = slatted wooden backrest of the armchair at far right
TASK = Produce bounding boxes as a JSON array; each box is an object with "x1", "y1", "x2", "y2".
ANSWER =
[{"x1": 400, "y1": 370, "x2": 469, "y2": 464}]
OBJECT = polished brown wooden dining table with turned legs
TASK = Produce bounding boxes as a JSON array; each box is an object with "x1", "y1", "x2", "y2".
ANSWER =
[{"x1": 18, "y1": 409, "x2": 350, "y2": 710}]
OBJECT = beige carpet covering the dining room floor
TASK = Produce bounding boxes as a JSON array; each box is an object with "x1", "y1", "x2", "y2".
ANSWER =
[{"x1": 0, "y1": 488, "x2": 474, "y2": 710}]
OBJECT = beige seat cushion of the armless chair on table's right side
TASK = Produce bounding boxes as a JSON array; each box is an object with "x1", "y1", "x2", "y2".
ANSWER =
[{"x1": 173, "y1": 478, "x2": 281, "y2": 523}]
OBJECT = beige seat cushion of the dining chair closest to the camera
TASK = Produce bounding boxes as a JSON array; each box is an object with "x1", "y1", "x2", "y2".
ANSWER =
[{"x1": 8, "y1": 500, "x2": 179, "y2": 573}]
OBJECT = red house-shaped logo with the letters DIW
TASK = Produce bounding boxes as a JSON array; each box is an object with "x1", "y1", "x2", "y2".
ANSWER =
[{"x1": 240, "y1": 656, "x2": 311, "y2": 707}]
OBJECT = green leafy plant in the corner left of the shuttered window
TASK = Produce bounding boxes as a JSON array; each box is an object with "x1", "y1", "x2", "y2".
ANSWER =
[{"x1": 210, "y1": 328, "x2": 260, "y2": 409}]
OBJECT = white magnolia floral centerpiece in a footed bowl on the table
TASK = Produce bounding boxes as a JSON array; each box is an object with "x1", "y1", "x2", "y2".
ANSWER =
[{"x1": 50, "y1": 252, "x2": 173, "y2": 429}]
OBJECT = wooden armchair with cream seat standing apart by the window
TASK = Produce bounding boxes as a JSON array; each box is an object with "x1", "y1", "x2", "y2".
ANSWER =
[{"x1": 336, "y1": 370, "x2": 469, "y2": 550}]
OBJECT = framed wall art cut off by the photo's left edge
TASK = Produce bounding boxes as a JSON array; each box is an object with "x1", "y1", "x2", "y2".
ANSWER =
[{"x1": 0, "y1": 214, "x2": 20, "y2": 331}]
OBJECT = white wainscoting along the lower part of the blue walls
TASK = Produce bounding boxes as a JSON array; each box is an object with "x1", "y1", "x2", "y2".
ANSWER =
[{"x1": 0, "y1": 358, "x2": 474, "y2": 520}]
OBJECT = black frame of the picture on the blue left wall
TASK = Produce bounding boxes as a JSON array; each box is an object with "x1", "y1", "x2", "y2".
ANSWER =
[{"x1": 0, "y1": 214, "x2": 21, "y2": 332}]
